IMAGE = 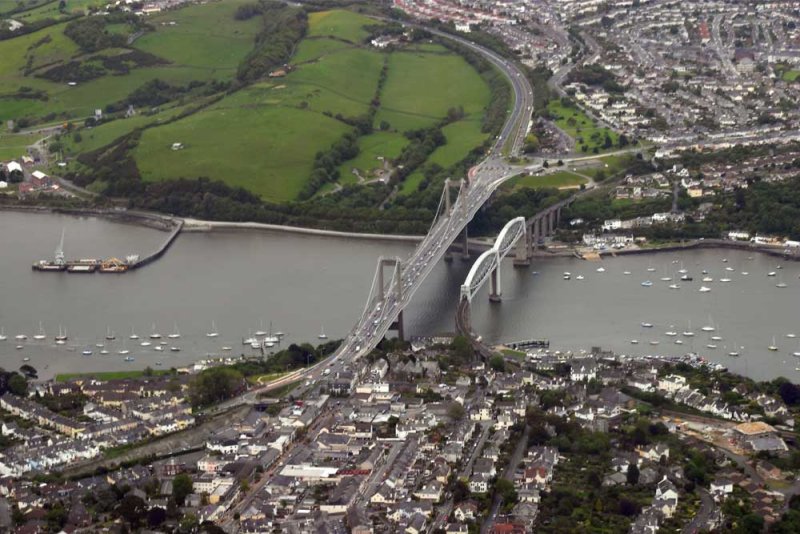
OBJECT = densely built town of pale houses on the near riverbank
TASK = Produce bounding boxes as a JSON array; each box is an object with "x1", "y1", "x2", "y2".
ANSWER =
[{"x1": 0, "y1": 337, "x2": 800, "y2": 533}]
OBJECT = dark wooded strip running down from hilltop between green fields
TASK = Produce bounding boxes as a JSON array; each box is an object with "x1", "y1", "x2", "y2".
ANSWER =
[{"x1": 236, "y1": 0, "x2": 308, "y2": 83}]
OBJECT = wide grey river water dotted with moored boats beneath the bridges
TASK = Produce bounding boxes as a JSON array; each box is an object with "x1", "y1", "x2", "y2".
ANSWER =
[{"x1": 0, "y1": 212, "x2": 800, "y2": 379}]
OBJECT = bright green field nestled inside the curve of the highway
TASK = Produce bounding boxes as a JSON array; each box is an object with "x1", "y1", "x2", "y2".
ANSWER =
[{"x1": 376, "y1": 47, "x2": 489, "y2": 132}]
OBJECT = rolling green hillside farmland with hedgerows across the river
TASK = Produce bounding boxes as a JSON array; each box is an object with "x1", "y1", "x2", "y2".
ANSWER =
[{"x1": 0, "y1": 0, "x2": 490, "y2": 211}]
